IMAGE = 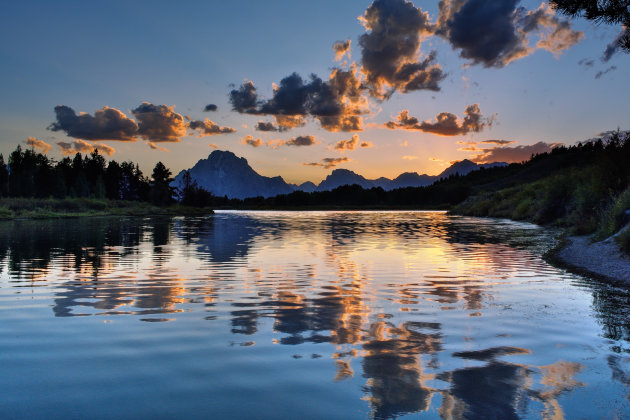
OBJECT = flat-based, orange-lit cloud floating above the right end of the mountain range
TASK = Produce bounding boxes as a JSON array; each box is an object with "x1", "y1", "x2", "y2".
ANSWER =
[{"x1": 385, "y1": 104, "x2": 493, "y2": 136}]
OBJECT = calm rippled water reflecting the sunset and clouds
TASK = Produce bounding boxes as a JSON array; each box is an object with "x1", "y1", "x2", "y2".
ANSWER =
[{"x1": 0, "y1": 212, "x2": 630, "y2": 419}]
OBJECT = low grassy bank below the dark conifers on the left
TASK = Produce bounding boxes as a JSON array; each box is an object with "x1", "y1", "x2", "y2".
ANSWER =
[{"x1": 0, "y1": 198, "x2": 212, "y2": 220}]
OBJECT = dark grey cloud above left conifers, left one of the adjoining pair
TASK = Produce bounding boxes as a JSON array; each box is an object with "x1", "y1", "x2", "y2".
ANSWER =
[{"x1": 48, "y1": 105, "x2": 138, "y2": 141}]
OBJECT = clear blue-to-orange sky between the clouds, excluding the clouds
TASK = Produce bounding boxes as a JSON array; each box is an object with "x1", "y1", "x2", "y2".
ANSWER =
[{"x1": 0, "y1": 0, "x2": 630, "y2": 182}]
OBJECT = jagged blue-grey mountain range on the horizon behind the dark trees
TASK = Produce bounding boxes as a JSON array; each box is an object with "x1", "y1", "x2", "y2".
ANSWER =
[{"x1": 172, "y1": 150, "x2": 507, "y2": 199}]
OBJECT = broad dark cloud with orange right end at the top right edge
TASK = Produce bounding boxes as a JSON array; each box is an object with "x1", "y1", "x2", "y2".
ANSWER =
[{"x1": 436, "y1": 0, "x2": 584, "y2": 68}]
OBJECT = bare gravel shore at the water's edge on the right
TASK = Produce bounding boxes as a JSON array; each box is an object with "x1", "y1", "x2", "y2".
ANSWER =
[{"x1": 554, "y1": 236, "x2": 630, "y2": 285}]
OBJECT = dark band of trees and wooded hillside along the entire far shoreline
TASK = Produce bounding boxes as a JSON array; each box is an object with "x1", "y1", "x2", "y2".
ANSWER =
[{"x1": 0, "y1": 130, "x2": 630, "y2": 282}]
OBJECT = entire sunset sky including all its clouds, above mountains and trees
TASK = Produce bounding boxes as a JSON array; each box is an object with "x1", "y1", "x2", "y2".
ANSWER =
[{"x1": 0, "y1": 0, "x2": 630, "y2": 183}]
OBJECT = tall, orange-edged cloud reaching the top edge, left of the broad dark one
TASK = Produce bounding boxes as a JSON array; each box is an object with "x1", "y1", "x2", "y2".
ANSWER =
[{"x1": 359, "y1": 0, "x2": 446, "y2": 99}]
